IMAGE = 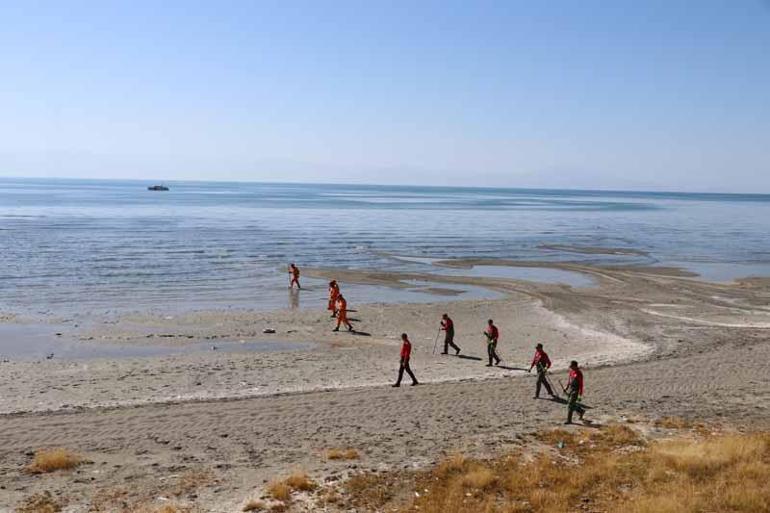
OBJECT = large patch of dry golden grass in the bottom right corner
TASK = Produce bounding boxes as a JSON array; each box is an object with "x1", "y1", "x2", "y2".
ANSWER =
[{"x1": 346, "y1": 425, "x2": 770, "y2": 513}]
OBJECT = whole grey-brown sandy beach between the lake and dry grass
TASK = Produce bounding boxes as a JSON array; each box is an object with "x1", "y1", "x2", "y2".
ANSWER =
[{"x1": 0, "y1": 260, "x2": 770, "y2": 512}]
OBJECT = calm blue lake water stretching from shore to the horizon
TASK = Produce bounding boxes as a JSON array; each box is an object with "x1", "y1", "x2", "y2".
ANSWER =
[{"x1": 0, "y1": 179, "x2": 770, "y2": 315}]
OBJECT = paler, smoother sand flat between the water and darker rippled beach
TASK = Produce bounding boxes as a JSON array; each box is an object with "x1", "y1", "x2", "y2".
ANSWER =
[{"x1": 0, "y1": 259, "x2": 770, "y2": 414}]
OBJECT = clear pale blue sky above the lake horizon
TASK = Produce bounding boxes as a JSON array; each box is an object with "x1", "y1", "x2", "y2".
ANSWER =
[{"x1": 0, "y1": 0, "x2": 770, "y2": 192}]
